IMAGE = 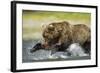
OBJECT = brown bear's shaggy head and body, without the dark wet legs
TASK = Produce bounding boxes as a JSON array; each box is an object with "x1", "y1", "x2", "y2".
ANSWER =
[{"x1": 42, "y1": 21, "x2": 91, "y2": 52}]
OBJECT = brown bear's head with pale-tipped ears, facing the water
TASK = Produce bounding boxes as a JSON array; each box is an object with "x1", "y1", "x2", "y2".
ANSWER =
[{"x1": 42, "y1": 23, "x2": 61, "y2": 45}]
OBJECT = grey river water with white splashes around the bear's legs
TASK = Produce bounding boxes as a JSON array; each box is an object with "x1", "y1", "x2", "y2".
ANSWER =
[{"x1": 22, "y1": 40, "x2": 90, "y2": 63}]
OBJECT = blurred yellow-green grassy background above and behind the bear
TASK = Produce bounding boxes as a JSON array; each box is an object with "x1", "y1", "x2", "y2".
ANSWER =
[{"x1": 23, "y1": 10, "x2": 91, "y2": 40}]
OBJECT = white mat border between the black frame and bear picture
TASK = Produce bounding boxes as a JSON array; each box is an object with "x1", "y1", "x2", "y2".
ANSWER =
[{"x1": 16, "y1": 4, "x2": 96, "y2": 70}]
